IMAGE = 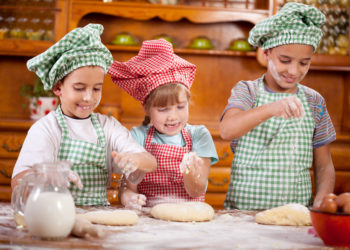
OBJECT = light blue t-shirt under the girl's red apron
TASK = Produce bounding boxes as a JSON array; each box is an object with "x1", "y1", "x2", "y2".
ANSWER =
[{"x1": 130, "y1": 124, "x2": 219, "y2": 165}]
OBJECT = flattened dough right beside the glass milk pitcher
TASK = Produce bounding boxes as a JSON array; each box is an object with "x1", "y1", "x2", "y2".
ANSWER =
[{"x1": 77, "y1": 210, "x2": 139, "y2": 226}]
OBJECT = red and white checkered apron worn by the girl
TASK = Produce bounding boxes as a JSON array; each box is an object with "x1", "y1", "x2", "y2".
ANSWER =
[{"x1": 137, "y1": 126, "x2": 205, "y2": 207}]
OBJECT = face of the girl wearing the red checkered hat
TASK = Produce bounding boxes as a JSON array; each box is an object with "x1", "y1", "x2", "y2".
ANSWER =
[{"x1": 147, "y1": 90, "x2": 188, "y2": 135}]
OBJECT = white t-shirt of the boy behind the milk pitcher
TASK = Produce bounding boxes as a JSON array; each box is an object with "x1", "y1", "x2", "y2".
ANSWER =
[{"x1": 12, "y1": 111, "x2": 145, "y2": 186}]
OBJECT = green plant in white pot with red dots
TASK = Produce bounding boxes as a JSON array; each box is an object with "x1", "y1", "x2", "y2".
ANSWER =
[{"x1": 21, "y1": 78, "x2": 58, "y2": 120}]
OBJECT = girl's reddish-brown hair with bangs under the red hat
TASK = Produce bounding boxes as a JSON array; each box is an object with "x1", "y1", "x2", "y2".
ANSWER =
[{"x1": 142, "y1": 82, "x2": 191, "y2": 126}]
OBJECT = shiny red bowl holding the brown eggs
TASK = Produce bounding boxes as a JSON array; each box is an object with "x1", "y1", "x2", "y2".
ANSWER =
[{"x1": 310, "y1": 209, "x2": 350, "y2": 247}]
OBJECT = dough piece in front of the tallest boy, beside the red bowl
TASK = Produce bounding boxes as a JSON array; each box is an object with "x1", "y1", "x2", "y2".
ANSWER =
[{"x1": 255, "y1": 203, "x2": 311, "y2": 226}]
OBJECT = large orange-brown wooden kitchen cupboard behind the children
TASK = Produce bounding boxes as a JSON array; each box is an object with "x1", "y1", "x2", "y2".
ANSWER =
[{"x1": 0, "y1": 0, "x2": 350, "y2": 207}]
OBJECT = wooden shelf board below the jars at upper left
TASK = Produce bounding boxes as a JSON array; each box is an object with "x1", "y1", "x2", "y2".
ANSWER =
[{"x1": 0, "y1": 39, "x2": 54, "y2": 56}]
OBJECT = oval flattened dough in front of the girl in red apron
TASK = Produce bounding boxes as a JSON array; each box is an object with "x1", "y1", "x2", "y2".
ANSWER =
[{"x1": 151, "y1": 202, "x2": 215, "y2": 222}]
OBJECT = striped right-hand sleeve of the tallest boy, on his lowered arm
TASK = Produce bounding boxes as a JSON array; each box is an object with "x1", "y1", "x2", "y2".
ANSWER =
[{"x1": 302, "y1": 85, "x2": 336, "y2": 148}]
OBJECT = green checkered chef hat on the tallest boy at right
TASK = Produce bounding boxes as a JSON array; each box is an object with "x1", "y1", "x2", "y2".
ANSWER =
[{"x1": 248, "y1": 2, "x2": 326, "y2": 51}]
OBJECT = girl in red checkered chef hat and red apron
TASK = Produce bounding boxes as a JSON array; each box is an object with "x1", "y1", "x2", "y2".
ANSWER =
[{"x1": 109, "y1": 39, "x2": 218, "y2": 206}]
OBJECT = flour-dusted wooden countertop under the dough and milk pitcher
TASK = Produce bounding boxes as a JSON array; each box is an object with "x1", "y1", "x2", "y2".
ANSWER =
[{"x1": 0, "y1": 202, "x2": 331, "y2": 250}]
